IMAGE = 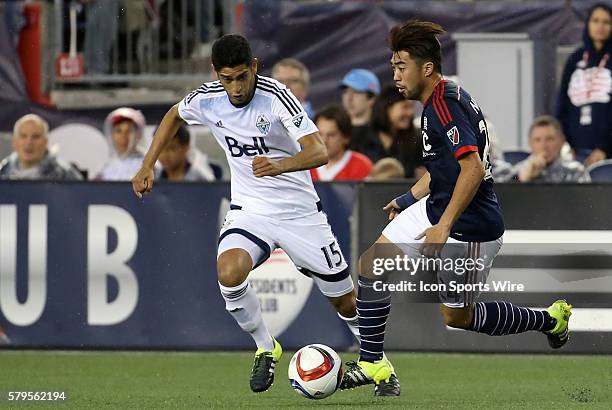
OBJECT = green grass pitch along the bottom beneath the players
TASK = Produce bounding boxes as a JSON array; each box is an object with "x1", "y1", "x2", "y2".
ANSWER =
[{"x1": 0, "y1": 351, "x2": 612, "y2": 410}]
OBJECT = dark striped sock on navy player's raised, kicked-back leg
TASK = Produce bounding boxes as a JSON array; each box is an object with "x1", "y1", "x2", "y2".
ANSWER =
[{"x1": 470, "y1": 301, "x2": 557, "y2": 336}]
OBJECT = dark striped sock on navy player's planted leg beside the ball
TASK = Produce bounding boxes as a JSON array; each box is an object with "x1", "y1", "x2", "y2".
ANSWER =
[{"x1": 357, "y1": 276, "x2": 391, "y2": 363}]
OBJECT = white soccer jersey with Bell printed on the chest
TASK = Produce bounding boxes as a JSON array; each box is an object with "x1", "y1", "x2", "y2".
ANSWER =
[{"x1": 178, "y1": 76, "x2": 319, "y2": 219}]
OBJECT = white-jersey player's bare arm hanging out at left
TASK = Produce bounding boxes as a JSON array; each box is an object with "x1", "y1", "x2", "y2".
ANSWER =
[{"x1": 132, "y1": 104, "x2": 184, "y2": 198}]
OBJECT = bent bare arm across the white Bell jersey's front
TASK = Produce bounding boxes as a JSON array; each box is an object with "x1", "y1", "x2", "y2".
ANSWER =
[{"x1": 253, "y1": 132, "x2": 328, "y2": 177}]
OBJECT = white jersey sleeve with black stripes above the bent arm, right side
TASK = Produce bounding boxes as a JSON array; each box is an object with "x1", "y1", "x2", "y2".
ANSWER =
[{"x1": 272, "y1": 88, "x2": 319, "y2": 140}]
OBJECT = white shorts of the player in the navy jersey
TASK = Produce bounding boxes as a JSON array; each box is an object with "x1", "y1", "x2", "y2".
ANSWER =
[{"x1": 382, "y1": 197, "x2": 503, "y2": 308}]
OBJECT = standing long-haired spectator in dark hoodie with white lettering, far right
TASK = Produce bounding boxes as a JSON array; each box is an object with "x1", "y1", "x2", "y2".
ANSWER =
[{"x1": 557, "y1": 3, "x2": 612, "y2": 165}]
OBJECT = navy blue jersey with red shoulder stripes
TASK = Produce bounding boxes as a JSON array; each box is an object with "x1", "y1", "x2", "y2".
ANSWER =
[{"x1": 421, "y1": 80, "x2": 504, "y2": 242}]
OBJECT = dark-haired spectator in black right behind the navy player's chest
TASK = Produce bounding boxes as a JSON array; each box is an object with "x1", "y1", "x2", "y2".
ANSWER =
[{"x1": 372, "y1": 85, "x2": 425, "y2": 178}]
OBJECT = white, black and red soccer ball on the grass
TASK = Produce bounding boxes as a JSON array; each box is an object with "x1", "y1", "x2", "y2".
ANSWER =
[{"x1": 289, "y1": 344, "x2": 342, "y2": 400}]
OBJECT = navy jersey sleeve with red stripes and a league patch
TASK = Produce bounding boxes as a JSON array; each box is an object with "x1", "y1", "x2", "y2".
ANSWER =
[{"x1": 432, "y1": 98, "x2": 478, "y2": 159}]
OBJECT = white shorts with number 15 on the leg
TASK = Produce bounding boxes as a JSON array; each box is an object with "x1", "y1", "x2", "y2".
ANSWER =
[{"x1": 217, "y1": 209, "x2": 353, "y2": 297}]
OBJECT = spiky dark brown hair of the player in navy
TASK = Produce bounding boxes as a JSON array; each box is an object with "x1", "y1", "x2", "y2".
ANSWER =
[{"x1": 387, "y1": 20, "x2": 445, "y2": 73}]
